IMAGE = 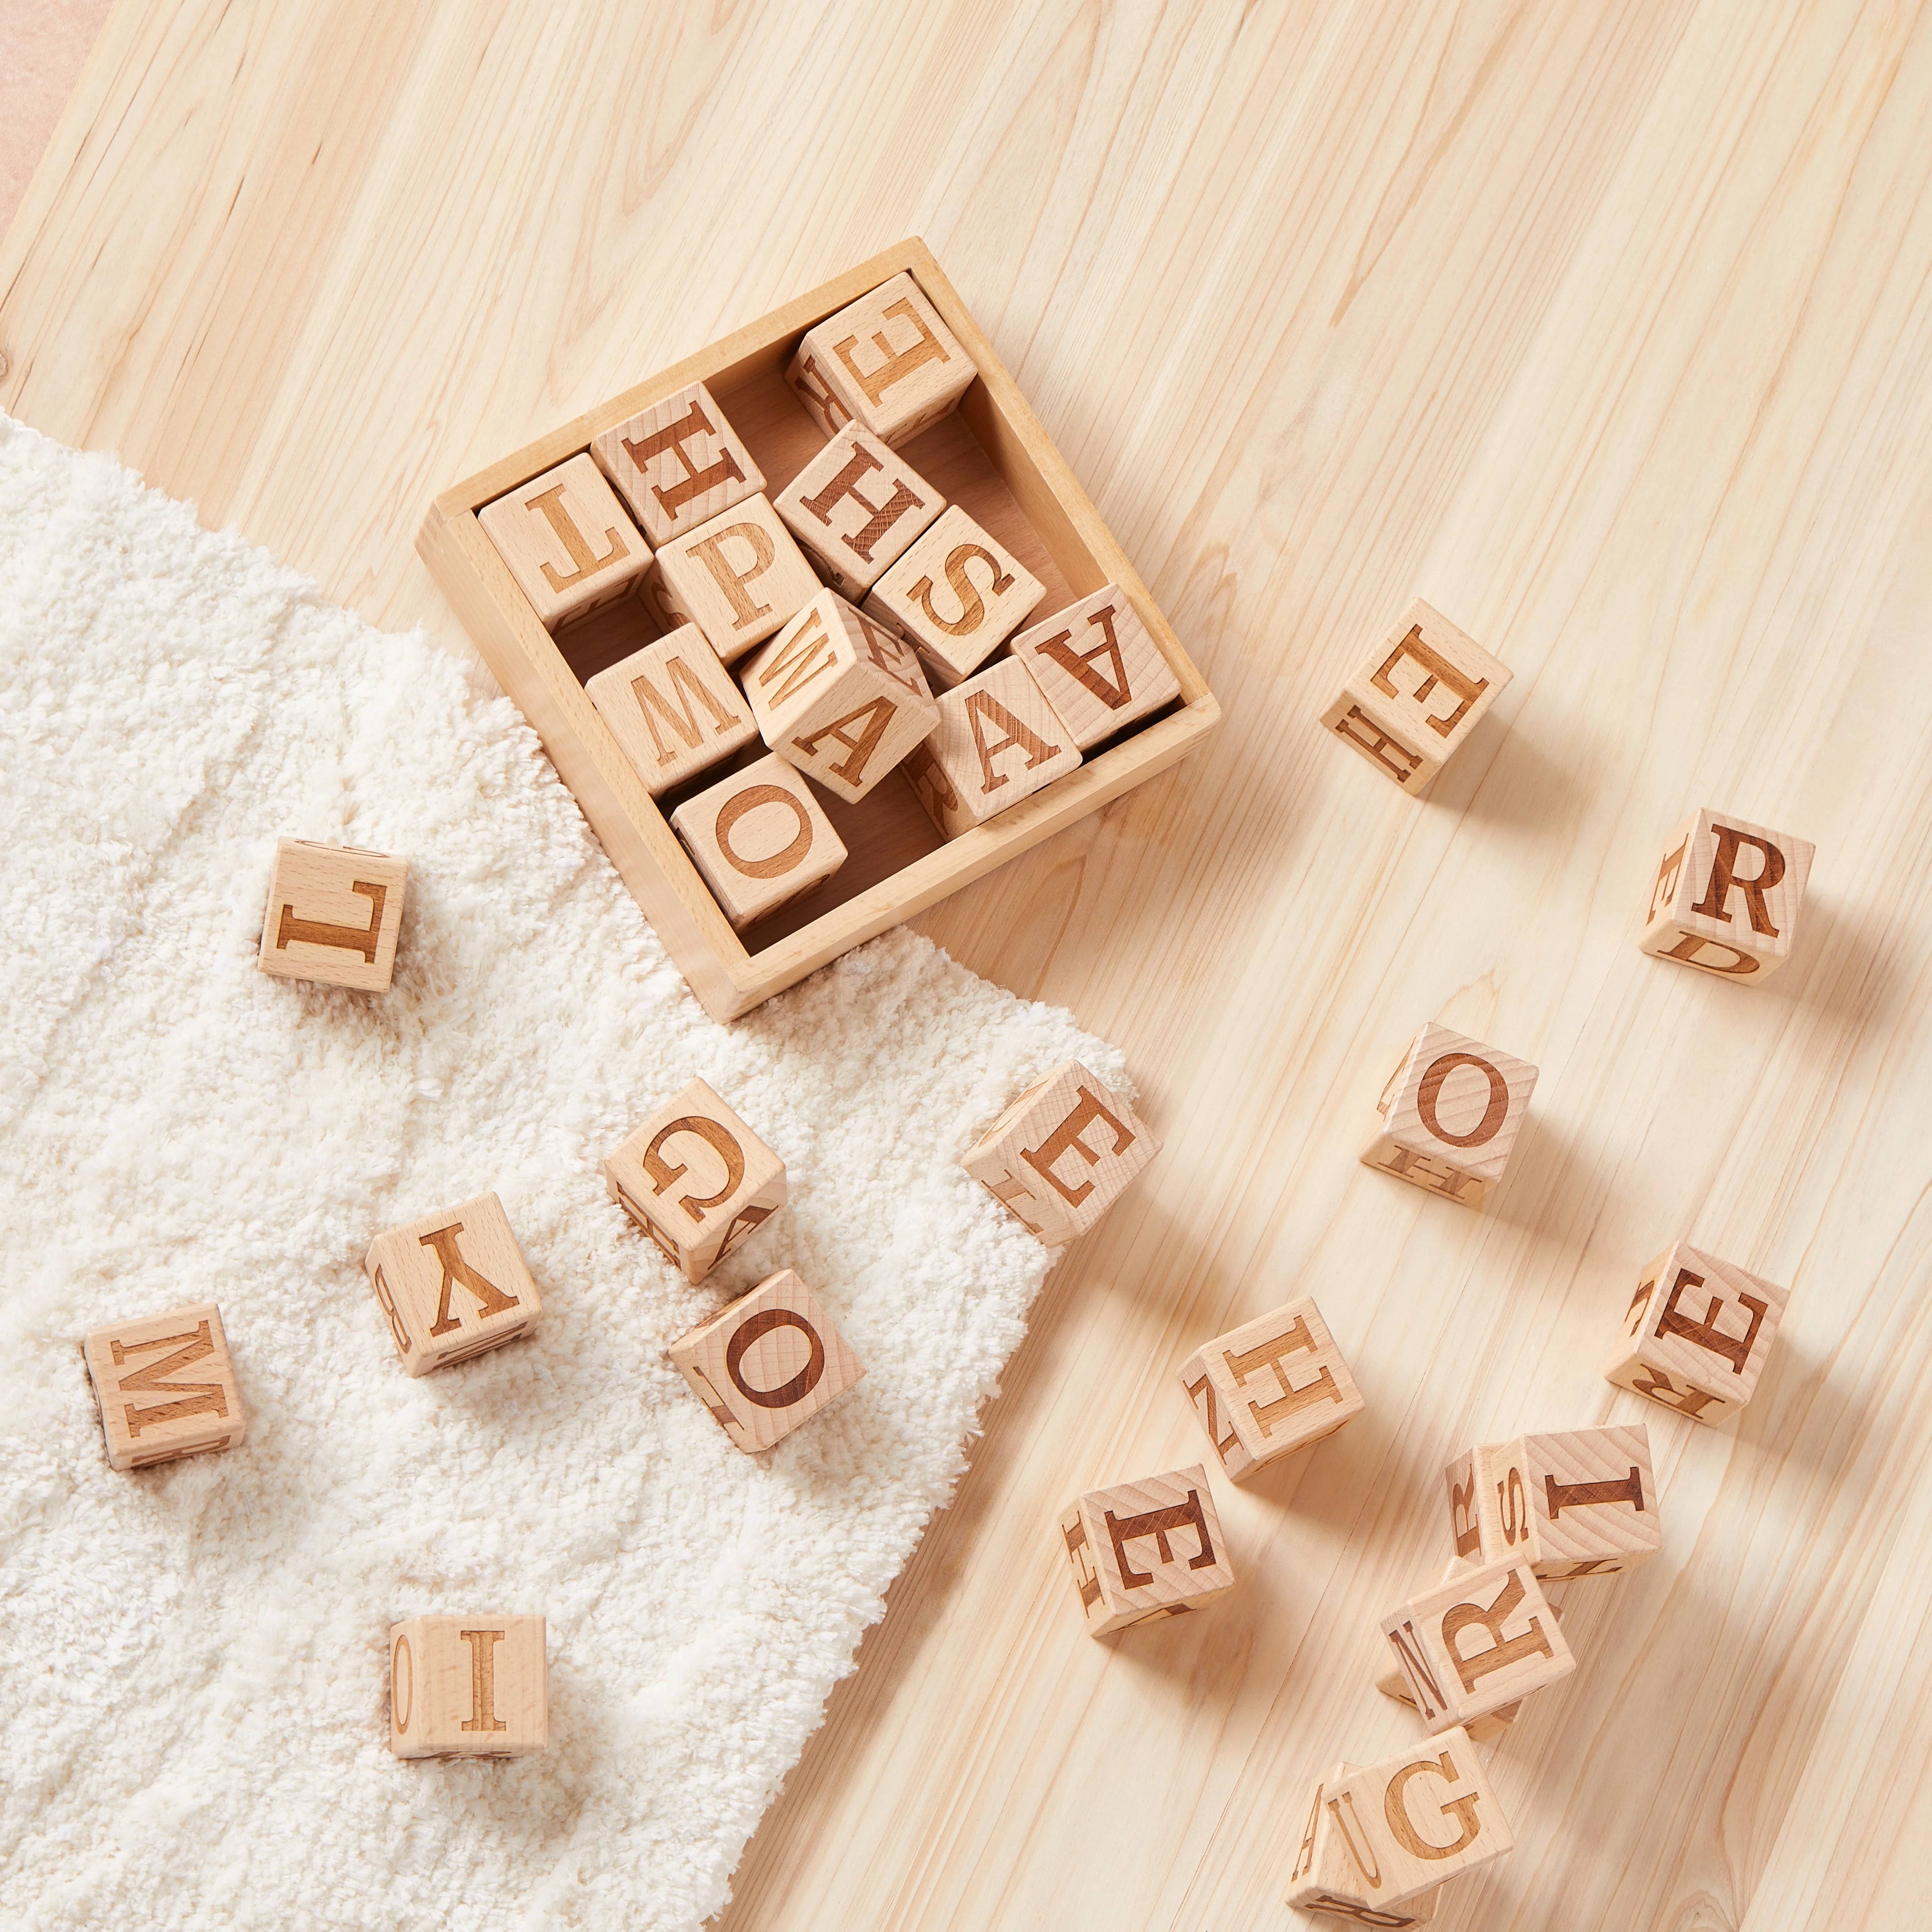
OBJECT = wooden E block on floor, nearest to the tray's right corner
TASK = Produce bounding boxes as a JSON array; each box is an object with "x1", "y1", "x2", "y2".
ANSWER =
[{"x1": 1322, "y1": 599, "x2": 1509, "y2": 794}]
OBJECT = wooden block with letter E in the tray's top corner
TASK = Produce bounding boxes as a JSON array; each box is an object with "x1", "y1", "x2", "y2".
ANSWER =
[{"x1": 784, "y1": 274, "x2": 980, "y2": 448}]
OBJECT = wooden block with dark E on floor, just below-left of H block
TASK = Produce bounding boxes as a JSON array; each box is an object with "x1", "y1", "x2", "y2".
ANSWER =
[{"x1": 1061, "y1": 1463, "x2": 1234, "y2": 1637}]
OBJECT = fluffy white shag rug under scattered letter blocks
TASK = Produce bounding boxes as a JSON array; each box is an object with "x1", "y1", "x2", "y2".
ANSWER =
[{"x1": 0, "y1": 417, "x2": 1122, "y2": 1932}]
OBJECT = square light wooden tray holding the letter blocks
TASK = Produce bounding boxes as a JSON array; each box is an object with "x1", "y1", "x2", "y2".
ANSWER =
[{"x1": 417, "y1": 240, "x2": 1221, "y2": 1020}]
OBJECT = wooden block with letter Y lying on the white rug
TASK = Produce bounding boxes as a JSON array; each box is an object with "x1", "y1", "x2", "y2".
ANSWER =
[{"x1": 363, "y1": 1194, "x2": 543, "y2": 1375}]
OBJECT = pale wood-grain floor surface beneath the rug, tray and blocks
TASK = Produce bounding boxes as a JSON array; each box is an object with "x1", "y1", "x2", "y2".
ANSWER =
[{"x1": 0, "y1": 0, "x2": 1932, "y2": 1932}]
